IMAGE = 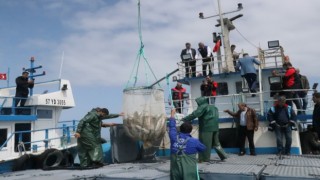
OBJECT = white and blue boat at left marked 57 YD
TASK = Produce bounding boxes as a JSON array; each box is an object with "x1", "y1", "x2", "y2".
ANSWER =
[{"x1": 0, "y1": 57, "x2": 76, "y2": 173}]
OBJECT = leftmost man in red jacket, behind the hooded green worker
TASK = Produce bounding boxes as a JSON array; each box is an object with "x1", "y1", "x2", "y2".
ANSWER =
[{"x1": 171, "y1": 82, "x2": 186, "y2": 113}]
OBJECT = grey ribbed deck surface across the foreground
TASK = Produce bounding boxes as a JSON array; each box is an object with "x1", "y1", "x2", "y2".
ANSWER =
[{"x1": 0, "y1": 154, "x2": 320, "y2": 180}]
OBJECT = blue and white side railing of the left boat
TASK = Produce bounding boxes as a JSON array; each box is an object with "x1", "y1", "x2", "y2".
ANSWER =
[{"x1": 0, "y1": 120, "x2": 78, "y2": 153}]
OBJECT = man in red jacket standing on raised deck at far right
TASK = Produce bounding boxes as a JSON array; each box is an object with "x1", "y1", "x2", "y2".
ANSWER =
[{"x1": 283, "y1": 62, "x2": 301, "y2": 114}]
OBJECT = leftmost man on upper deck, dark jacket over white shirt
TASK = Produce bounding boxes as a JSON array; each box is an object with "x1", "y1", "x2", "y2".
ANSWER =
[{"x1": 180, "y1": 42, "x2": 197, "y2": 77}]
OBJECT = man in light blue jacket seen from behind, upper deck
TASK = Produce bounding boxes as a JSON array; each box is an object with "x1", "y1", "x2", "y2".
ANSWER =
[{"x1": 236, "y1": 53, "x2": 260, "y2": 97}]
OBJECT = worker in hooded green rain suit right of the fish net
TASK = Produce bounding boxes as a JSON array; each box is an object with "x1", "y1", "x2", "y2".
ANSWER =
[{"x1": 182, "y1": 97, "x2": 227, "y2": 163}]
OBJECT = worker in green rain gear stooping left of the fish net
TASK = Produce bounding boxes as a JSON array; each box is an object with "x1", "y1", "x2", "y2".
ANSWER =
[{"x1": 74, "y1": 108, "x2": 122, "y2": 167}]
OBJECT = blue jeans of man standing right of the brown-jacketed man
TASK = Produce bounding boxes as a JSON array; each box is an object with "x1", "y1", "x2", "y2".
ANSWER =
[{"x1": 275, "y1": 124, "x2": 292, "y2": 154}]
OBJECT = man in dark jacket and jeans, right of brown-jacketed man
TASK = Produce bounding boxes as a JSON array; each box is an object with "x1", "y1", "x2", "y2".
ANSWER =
[{"x1": 268, "y1": 96, "x2": 296, "y2": 155}]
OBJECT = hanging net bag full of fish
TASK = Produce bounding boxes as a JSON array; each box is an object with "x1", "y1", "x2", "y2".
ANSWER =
[{"x1": 123, "y1": 87, "x2": 166, "y2": 149}]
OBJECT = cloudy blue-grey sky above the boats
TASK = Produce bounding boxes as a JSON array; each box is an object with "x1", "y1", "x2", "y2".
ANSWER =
[{"x1": 0, "y1": 0, "x2": 320, "y2": 124}]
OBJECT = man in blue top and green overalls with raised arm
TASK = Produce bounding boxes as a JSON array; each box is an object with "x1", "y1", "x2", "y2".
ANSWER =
[{"x1": 169, "y1": 109, "x2": 206, "y2": 180}]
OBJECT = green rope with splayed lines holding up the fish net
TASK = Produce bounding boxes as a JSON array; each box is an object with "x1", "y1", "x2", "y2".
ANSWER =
[{"x1": 126, "y1": 0, "x2": 160, "y2": 88}]
